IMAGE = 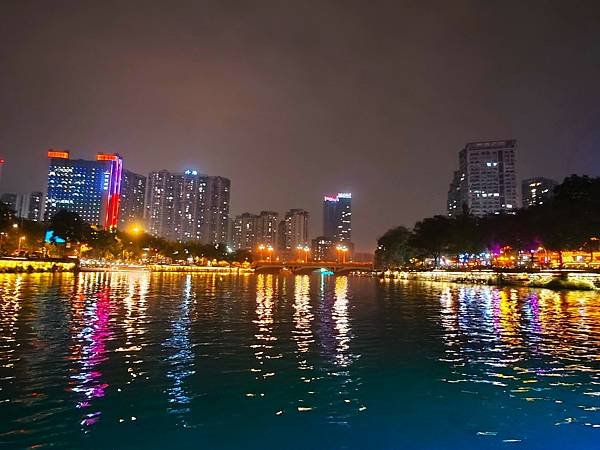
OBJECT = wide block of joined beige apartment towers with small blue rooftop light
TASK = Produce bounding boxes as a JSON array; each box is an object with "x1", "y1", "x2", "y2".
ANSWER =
[{"x1": 146, "y1": 170, "x2": 231, "y2": 244}]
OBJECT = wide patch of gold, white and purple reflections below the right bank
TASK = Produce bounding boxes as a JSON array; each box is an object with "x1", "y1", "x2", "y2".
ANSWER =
[{"x1": 440, "y1": 287, "x2": 600, "y2": 426}]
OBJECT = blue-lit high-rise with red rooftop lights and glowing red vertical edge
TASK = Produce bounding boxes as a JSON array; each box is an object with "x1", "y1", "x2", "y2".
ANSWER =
[{"x1": 45, "y1": 150, "x2": 123, "y2": 230}]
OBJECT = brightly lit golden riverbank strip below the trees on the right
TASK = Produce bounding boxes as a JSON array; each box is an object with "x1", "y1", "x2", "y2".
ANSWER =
[{"x1": 380, "y1": 270, "x2": 600, "y2": 291}]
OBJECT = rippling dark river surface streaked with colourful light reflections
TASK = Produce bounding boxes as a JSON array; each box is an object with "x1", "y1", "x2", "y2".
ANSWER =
[{"x1": 0, "y1": 273, "x2": 600, "y2": 449}]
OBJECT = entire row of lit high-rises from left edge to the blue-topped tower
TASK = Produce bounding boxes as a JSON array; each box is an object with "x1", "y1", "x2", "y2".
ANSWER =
[{"x1": 0, "y1": 149, "x2": 353, "y2": 261}]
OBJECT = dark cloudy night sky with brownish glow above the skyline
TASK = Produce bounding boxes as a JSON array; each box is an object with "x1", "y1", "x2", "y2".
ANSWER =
[{"x1": 0, "y1": 0, "x2": 600, "y2": 250}]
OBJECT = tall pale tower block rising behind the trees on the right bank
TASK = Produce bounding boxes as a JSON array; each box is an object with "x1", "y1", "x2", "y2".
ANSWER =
[{"x1": 448, "y1": 140, "x2": 517, "y2": 217}]
